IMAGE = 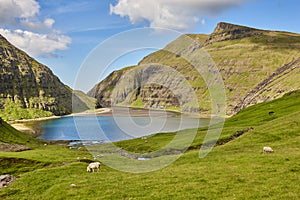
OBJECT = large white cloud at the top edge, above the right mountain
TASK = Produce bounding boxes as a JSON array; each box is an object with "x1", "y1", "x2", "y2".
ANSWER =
[{"x1": 110, "y1": 0, "x2": 246, "y2": 30}]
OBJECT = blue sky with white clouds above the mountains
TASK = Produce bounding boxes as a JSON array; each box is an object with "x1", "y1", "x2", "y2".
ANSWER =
[{"x1": 0, "y1": 0, "x2": 300, "y2": 92}]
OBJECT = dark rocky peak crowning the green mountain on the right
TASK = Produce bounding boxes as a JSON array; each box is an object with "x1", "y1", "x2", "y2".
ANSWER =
[{"x1": 204, "y1": 22, "x2": 262, "y2": 46}]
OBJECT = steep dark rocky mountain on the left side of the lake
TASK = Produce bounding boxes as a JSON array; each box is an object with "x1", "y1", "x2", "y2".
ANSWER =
[{"x1": 0, "y1": 35, "x2": 94, "y2": 119}]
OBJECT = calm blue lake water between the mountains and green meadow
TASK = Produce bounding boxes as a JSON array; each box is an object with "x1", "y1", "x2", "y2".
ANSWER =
[{"x1": 39, "y1": 116, "x2": 209, "y2": 142}]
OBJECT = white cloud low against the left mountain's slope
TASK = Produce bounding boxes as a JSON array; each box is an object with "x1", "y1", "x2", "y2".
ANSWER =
[{"x1": 0, "y1": 28, "x2": 72, "y2": 56}]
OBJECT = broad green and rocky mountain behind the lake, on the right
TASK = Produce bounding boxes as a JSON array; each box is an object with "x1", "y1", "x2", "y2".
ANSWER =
[{"x1": 88, "y1": 22, "x2": 300, "y2": 115}]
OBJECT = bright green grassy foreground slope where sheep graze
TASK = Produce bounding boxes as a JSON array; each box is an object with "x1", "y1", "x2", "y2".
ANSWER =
[{"x1": 0, "y1": 92, "x2": 300, "y2": 199}]
